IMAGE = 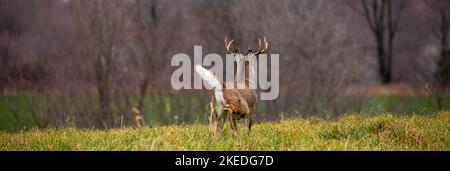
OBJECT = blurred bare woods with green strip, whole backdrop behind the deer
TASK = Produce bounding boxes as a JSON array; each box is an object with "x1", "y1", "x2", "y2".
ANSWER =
[{"x1": 0, "y1": 0, "x2": 450, "y2": 130}]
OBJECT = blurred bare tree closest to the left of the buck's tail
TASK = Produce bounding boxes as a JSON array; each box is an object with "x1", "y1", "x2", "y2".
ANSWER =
[{"x1": 130, "y1": 0, "x2": 179, "y2": 123}]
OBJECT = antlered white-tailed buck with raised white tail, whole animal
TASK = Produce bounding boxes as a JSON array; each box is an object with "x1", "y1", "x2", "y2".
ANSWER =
[{"x1": 201, "y1": 37, "x2": 268, "y2": 133}]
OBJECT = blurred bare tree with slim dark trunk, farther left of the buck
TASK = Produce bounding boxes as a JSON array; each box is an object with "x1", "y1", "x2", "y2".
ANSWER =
[{"x1": 71, "y1": 0, "x2": 126, "y2": 128}]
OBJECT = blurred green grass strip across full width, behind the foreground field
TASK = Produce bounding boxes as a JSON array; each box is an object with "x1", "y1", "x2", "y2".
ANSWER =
[{"x1": 0, "y1": 93, "x2": 450, "y2": 132}]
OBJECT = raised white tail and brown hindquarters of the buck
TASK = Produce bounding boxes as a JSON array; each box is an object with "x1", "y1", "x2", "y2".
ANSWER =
[{"x1": 195, "y1": 65, "x2": 251, "y2": 135}]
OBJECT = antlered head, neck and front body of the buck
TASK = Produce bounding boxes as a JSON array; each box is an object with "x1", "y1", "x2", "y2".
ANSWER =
[{"x1": 221, "y1": 37, "x2": 269, "y2": 132}]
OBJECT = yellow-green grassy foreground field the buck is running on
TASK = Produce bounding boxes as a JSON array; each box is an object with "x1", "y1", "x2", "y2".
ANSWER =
[{"x1": 0, "y1": 112, "x2": 450, "y2": 150}]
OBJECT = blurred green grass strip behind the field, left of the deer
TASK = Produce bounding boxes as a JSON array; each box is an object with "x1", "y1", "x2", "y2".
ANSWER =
[{"x1": 0, "y1": 93, "x2": 209, "y2": 132}]
